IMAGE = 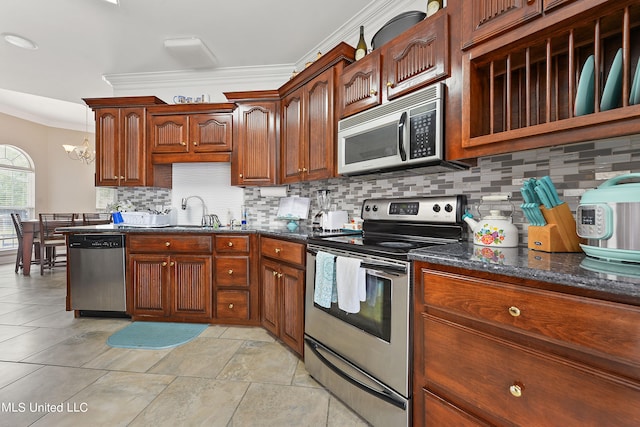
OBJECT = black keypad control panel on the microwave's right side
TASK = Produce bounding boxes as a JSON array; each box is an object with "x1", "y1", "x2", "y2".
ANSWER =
[{"x1": 409, "y1": 102, "x2": 438, "y2": 159}]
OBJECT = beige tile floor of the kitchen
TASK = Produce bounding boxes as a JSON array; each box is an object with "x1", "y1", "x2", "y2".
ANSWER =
[{"x1": 0, "y1": 265, "x2": 367, "y2": 427}]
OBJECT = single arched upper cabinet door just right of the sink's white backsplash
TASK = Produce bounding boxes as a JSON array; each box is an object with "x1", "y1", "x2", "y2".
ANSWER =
[{"x1": 231, "y1": 101, "x2": 278, "y2": 185}]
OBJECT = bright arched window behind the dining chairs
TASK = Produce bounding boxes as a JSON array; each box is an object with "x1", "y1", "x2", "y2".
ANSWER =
[{"x1": 0, "y1": 144, "x2": 35, "y2": 250}]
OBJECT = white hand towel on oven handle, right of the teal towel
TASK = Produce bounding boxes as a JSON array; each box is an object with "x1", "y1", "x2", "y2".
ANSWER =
[{"x1": 336, "y1": 256, "x2": 367, "y2": 313}]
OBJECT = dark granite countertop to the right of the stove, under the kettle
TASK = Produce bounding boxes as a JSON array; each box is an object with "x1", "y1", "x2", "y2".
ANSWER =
[{"x1": 409, "y1": 243, "x2": 640, "y2": 305}]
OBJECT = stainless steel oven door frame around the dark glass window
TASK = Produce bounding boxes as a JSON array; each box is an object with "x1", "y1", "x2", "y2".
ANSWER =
[{"x1": 305, "y1": 244, "x2": 411, "y2": 396}]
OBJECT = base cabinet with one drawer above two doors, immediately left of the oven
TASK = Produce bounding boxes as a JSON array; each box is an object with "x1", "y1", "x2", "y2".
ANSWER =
[{"x1": 260, "y1": 237, "x2": 305, "y2": 357}]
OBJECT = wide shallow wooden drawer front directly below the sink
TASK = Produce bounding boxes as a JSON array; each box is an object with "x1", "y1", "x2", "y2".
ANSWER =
[{"x1": 127, "y1": 234, "x2": 213, "y2": 254}]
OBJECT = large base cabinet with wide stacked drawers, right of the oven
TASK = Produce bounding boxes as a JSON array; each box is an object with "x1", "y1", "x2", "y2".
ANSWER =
[{"x1": 413, "y1": 262, "x2": 640, "y2": 426}]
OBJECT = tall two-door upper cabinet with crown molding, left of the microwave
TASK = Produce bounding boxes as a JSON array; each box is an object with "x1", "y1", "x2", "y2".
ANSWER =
[{"x1": 279, "y1": 43, "x2": 354, "y2": 184}]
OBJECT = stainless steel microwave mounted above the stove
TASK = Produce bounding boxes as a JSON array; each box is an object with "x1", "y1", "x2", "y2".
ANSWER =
[{"x1": 338, "y1": 83, "x2": 466, "y2": 175}]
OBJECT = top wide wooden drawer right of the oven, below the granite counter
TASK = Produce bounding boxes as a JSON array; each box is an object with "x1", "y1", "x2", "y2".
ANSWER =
[{"x1": 422, "y1": 271, "x2": 640, "y2": 366}]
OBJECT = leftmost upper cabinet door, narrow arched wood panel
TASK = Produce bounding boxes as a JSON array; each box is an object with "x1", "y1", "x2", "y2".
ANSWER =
[{"x1": 96, "y1": 108, "x2": 120, "y2": 187}]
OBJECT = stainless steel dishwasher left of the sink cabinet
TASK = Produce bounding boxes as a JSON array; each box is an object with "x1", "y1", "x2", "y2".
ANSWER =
[{"x1": 67, "y1": 233, "x2": 126, "y2": 316}]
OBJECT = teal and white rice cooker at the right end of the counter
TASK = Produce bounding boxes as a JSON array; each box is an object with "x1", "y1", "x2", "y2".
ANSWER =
[{"x1": 576, "y1": 173, "x2": 640, "y2": 263}]
